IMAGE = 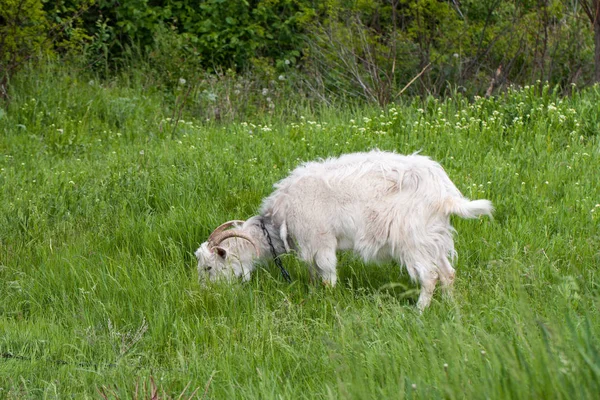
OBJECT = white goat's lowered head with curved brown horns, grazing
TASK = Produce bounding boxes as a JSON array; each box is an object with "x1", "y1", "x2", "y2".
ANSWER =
[{"x1": 195, "y1": 221, "x2": 259, "y2": 281}]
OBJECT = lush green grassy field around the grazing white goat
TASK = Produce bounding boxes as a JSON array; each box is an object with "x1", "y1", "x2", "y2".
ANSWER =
[{"x1": 0, "y1": 64, "x2": 600, "y2": 399}]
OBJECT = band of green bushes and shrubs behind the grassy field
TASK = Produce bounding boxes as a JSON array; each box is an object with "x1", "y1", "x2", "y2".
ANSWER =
[{"x1": 0, "y1": 0, "x2": 594, "y2": 105}]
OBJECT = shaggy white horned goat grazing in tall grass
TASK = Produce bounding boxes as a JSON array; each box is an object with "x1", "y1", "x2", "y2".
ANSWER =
[{"x1": 195, "y1": 151, "x2": 493, "y2": 310}]
